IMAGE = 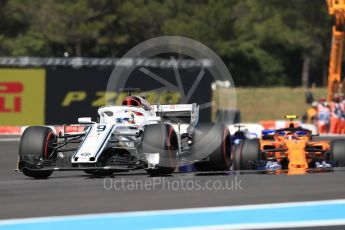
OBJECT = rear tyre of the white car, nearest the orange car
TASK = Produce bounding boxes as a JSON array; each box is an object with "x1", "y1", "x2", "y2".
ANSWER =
[{"x1": 192, "y1": 124, "x2": 232, "y2": 171}]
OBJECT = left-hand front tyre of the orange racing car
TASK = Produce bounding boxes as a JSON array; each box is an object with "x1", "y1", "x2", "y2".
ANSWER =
[{"x1": 233, "y1": 139, "x2": 260, "y2": 170}]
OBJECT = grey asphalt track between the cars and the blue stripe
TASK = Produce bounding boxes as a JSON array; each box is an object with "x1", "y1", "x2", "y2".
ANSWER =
[{"x1": 0, "y1": 137, "x2": 345, "y2": 226}]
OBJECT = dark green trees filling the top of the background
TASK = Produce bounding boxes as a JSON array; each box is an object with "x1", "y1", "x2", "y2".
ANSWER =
[{"x1": 0, "y1": 0, "x2": 331, "y2": 86}]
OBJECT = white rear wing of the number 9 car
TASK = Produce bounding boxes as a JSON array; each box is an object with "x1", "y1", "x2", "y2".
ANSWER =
[{"x1": 153, "y1": 103, "x2": 199, "y2": 124}]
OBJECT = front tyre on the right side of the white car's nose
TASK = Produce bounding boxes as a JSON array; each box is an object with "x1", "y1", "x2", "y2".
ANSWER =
[{"x1": 139, "y1": 124, "x2": 178, "y2": 176}]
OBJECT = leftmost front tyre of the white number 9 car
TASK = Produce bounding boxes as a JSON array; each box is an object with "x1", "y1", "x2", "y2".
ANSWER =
[{"x1": 18, "y1": 126, "x2": 56, "y2": 179}]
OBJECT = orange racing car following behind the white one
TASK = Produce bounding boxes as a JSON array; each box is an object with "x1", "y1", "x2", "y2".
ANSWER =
[{"x1": 233, "y1": 115, "x2": 345, "y2": 174}]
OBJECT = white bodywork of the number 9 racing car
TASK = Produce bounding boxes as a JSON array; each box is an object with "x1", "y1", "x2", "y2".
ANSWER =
[{"x1": 71, "y1": 104, "x2": 199, "y2": 164}]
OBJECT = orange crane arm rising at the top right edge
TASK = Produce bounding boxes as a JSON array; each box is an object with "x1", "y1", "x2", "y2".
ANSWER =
[{"x1": 327, "y1": 0, "x2": 345, "y2": 101}]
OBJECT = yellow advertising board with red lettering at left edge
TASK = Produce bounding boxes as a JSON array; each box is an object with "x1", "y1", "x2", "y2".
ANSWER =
[{"x1": 0, "y1": 69, "x2": 45, "y2": 125}]
